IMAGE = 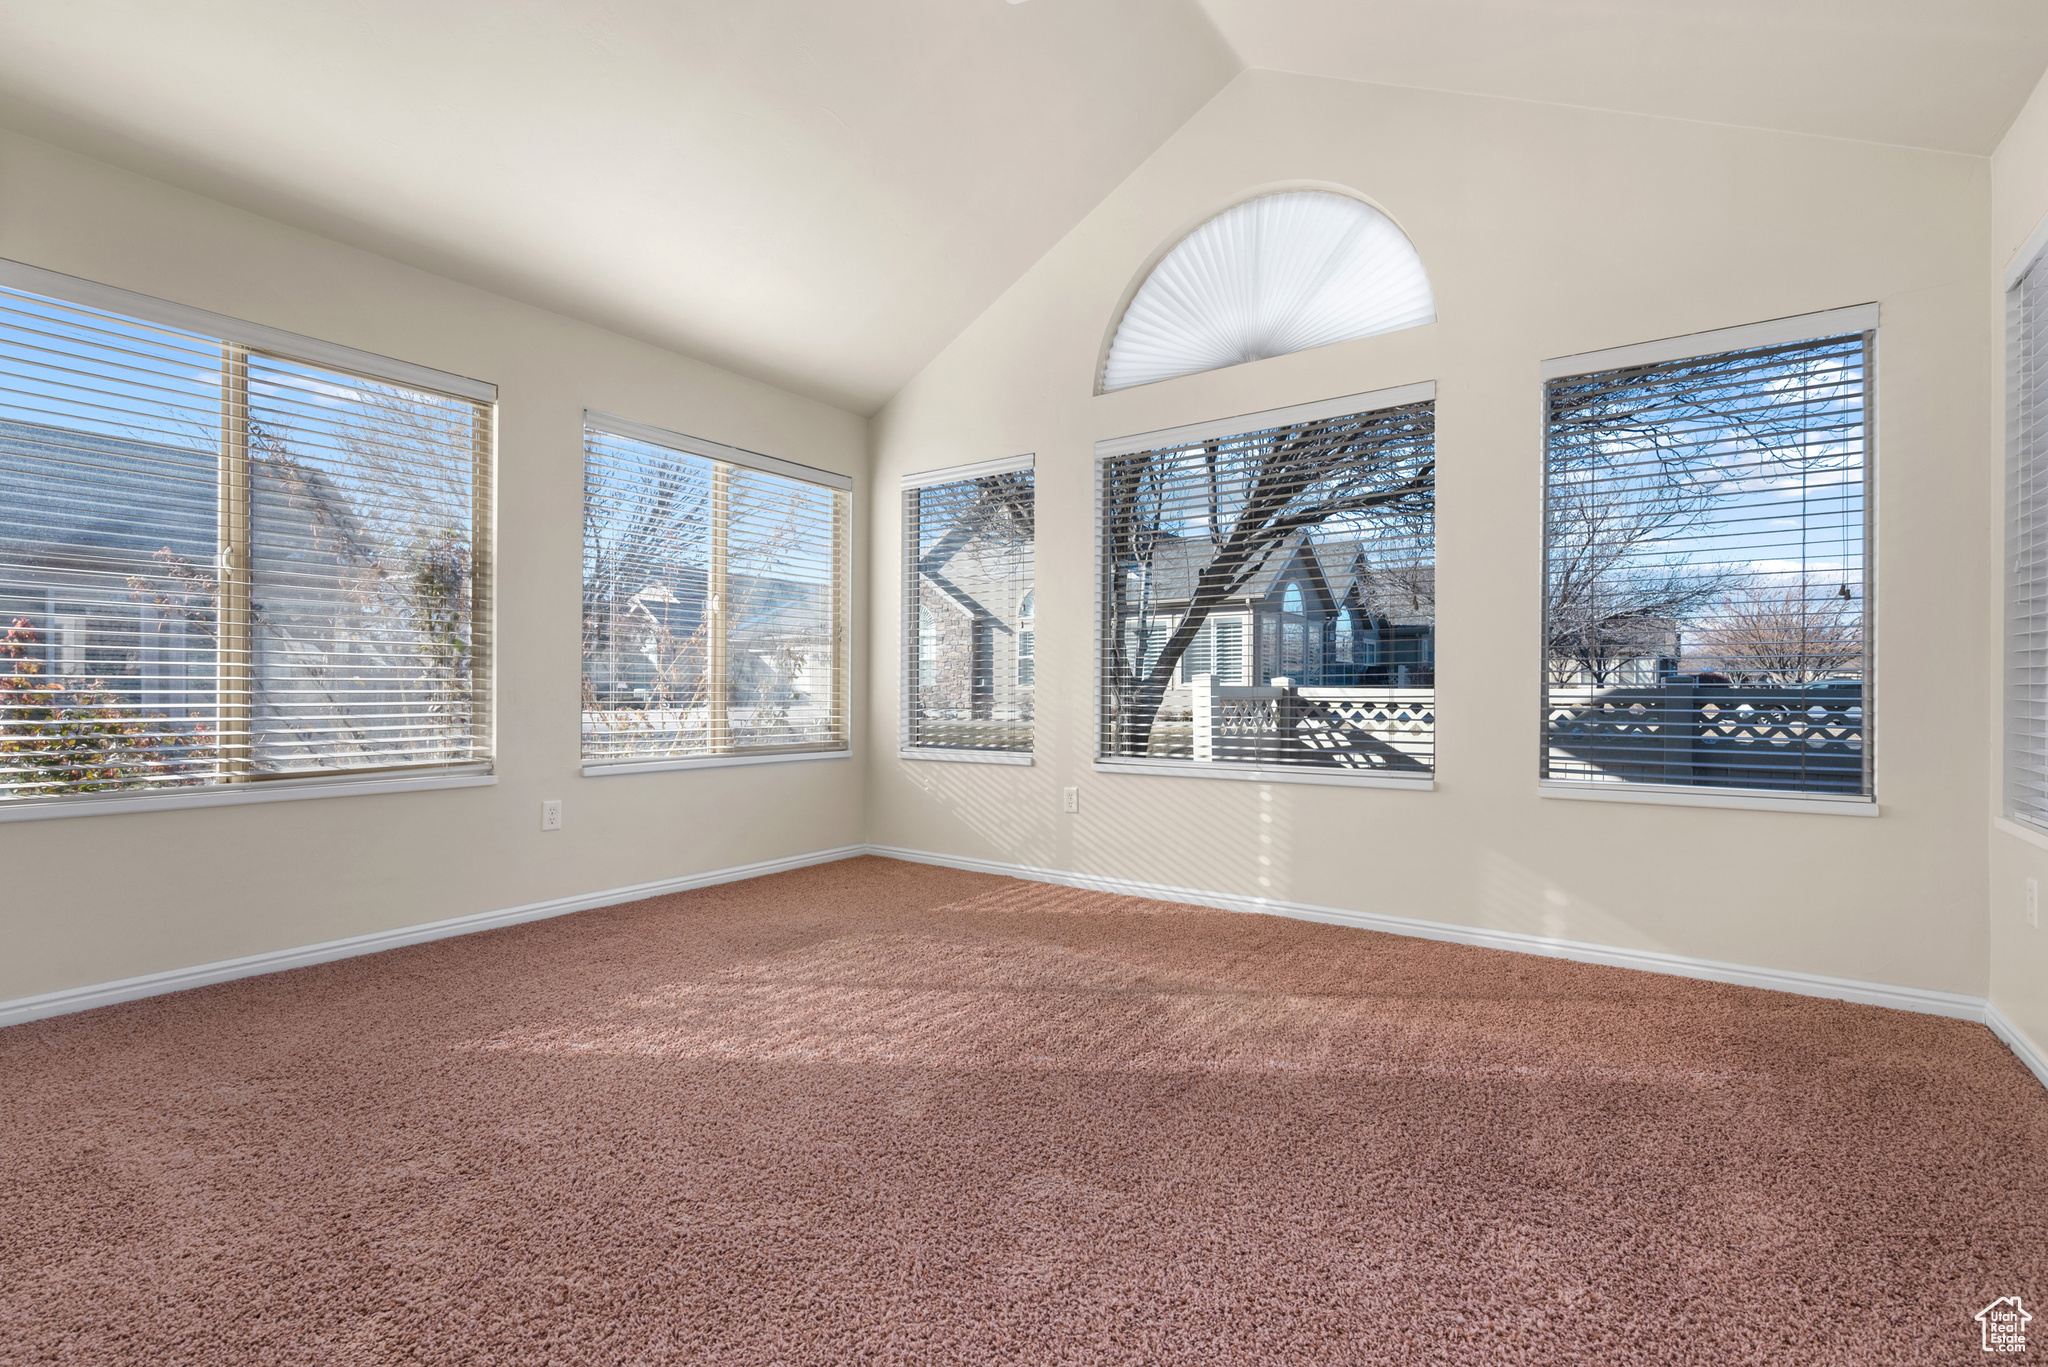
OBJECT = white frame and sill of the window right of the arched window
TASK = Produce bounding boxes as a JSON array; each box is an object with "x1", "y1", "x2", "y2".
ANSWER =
[{"x1": 1536, "y1": 303, "x2": 1882, "y2": 816}]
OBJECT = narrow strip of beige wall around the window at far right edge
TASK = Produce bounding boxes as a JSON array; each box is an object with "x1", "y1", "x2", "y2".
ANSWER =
[{"x1": 1982, "y1": 66, "x2": 2048, "y2": 1051}]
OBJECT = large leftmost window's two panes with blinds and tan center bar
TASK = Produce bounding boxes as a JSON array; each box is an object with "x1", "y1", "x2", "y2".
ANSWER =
[{"x1": 0, "y1": 262, "x2": 496, "y2": 816}]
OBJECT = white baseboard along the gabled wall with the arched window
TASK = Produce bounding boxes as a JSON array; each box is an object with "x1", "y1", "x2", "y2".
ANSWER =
[{"x1": 868, "y1": 844, "x2": 1987, "y2": 1023}]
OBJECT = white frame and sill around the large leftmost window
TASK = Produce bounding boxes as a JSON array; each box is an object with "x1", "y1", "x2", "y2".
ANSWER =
[{"x1": 0, "y1": 258, "x2": 498, "y2": 824}]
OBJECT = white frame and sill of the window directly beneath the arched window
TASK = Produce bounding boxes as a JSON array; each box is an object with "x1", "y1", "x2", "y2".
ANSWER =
[{"x1": 1090, "y1": 379, "x2": 1442, "y2": 793}]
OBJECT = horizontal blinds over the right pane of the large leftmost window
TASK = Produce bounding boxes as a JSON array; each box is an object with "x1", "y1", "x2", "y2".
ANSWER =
[{"x1": 237, "y1": 353, "x2": 489, "y2": 777}]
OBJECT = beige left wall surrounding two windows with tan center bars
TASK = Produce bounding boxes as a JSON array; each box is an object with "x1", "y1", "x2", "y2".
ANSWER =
[{"x1": 0, "y1": 133, "x2": 866, "y2": 1000}]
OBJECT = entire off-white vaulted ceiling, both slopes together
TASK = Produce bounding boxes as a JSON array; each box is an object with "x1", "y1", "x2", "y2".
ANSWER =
[{"x1": 0, "y1": 0, "x2": 2048, "y2": 412}]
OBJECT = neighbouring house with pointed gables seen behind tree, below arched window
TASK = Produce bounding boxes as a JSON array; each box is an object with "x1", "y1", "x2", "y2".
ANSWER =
[{"x1": 1124, "y1": 537, "x2": 1436, "y2": 689}]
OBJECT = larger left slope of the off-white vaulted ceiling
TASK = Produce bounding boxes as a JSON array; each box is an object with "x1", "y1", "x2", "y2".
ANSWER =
[{"x1": 0, "y1": 0, "x2": 1237, "y2": 412}]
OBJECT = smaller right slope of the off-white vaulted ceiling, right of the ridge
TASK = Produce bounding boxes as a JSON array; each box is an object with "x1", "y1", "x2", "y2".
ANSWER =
[{"x1": 1200, "y1": 0, "x2": 2048, "y2": 156}]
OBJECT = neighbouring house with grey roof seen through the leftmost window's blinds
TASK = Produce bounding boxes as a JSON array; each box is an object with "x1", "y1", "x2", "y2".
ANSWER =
[{"x1": 0, "y1": 422, "x2": 469, "y2": 773}]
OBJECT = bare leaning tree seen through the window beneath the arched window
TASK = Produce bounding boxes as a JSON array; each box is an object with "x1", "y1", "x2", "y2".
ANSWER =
[{"x1": 1102, "y1": 404, "x2": 1436, "y2": 754}]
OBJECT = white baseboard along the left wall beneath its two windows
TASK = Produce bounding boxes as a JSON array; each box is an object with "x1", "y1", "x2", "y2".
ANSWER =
[{"x1": 0, "y1": 844, "x2": 868, "y2": 1027}]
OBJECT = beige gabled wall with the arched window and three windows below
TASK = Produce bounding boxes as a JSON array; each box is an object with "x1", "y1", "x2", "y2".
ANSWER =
[{"x1": 868, "y1": 72, "x2": 1991, "y2": 994}]
